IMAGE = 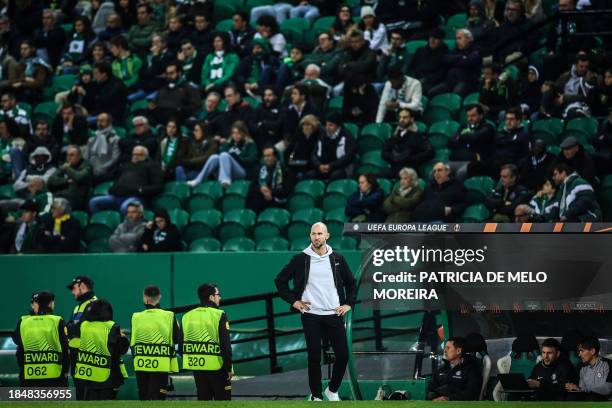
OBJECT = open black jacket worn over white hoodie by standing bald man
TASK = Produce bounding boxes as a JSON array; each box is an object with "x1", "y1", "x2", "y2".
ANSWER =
[{"x1": 274, "y1": 252, "x2": 356, "y2": 312}]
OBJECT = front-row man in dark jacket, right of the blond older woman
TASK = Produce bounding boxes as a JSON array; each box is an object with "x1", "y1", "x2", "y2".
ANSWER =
[{"x1": 414, "y1": 162, "x2": 467, "y2": 222}]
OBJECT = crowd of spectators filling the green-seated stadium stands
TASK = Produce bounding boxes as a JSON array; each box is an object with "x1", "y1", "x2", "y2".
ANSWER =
[{"x1": 0, "y1": 0, "x2": 612, "y2": 252}]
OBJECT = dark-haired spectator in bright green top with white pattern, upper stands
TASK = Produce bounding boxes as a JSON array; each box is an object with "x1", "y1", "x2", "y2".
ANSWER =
[{"x1": 200, "y1": 34, "x2": 240, "y2": 92}]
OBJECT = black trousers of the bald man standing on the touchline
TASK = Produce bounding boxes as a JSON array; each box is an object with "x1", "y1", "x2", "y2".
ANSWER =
[{"x1": 302, "y1": 313, "x2": 348, "y2": 399}]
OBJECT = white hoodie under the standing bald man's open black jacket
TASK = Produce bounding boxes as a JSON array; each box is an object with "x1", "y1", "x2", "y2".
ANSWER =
[{"x1": 302, "y1": 245, "x2": 340, "y2": 315}]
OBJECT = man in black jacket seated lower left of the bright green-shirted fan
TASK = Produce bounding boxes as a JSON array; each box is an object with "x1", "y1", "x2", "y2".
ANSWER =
[{"x1": 152, "y1": 61, "x2": 202, "y2": 123}]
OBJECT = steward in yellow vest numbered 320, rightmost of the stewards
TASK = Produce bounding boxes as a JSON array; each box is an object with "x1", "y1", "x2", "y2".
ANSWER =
[{"x1": 180, "y1": 283, "x2": 234, "y2": 401}]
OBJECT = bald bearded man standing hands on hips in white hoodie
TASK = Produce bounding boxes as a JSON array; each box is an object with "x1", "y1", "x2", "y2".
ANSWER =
[{"x1": 274, "y1": 222, "x2": 355, "y2": 401}]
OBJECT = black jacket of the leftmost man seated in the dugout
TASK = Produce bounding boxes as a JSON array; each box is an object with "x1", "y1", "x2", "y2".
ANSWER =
[{"x1": 427, "y1": 355, "x2": 482, "y2": 401}]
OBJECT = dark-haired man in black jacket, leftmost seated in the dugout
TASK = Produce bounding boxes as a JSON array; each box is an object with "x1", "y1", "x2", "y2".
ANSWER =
[{"x1": 427, "y1": 337, "x2": 482, "y2": 401}]
